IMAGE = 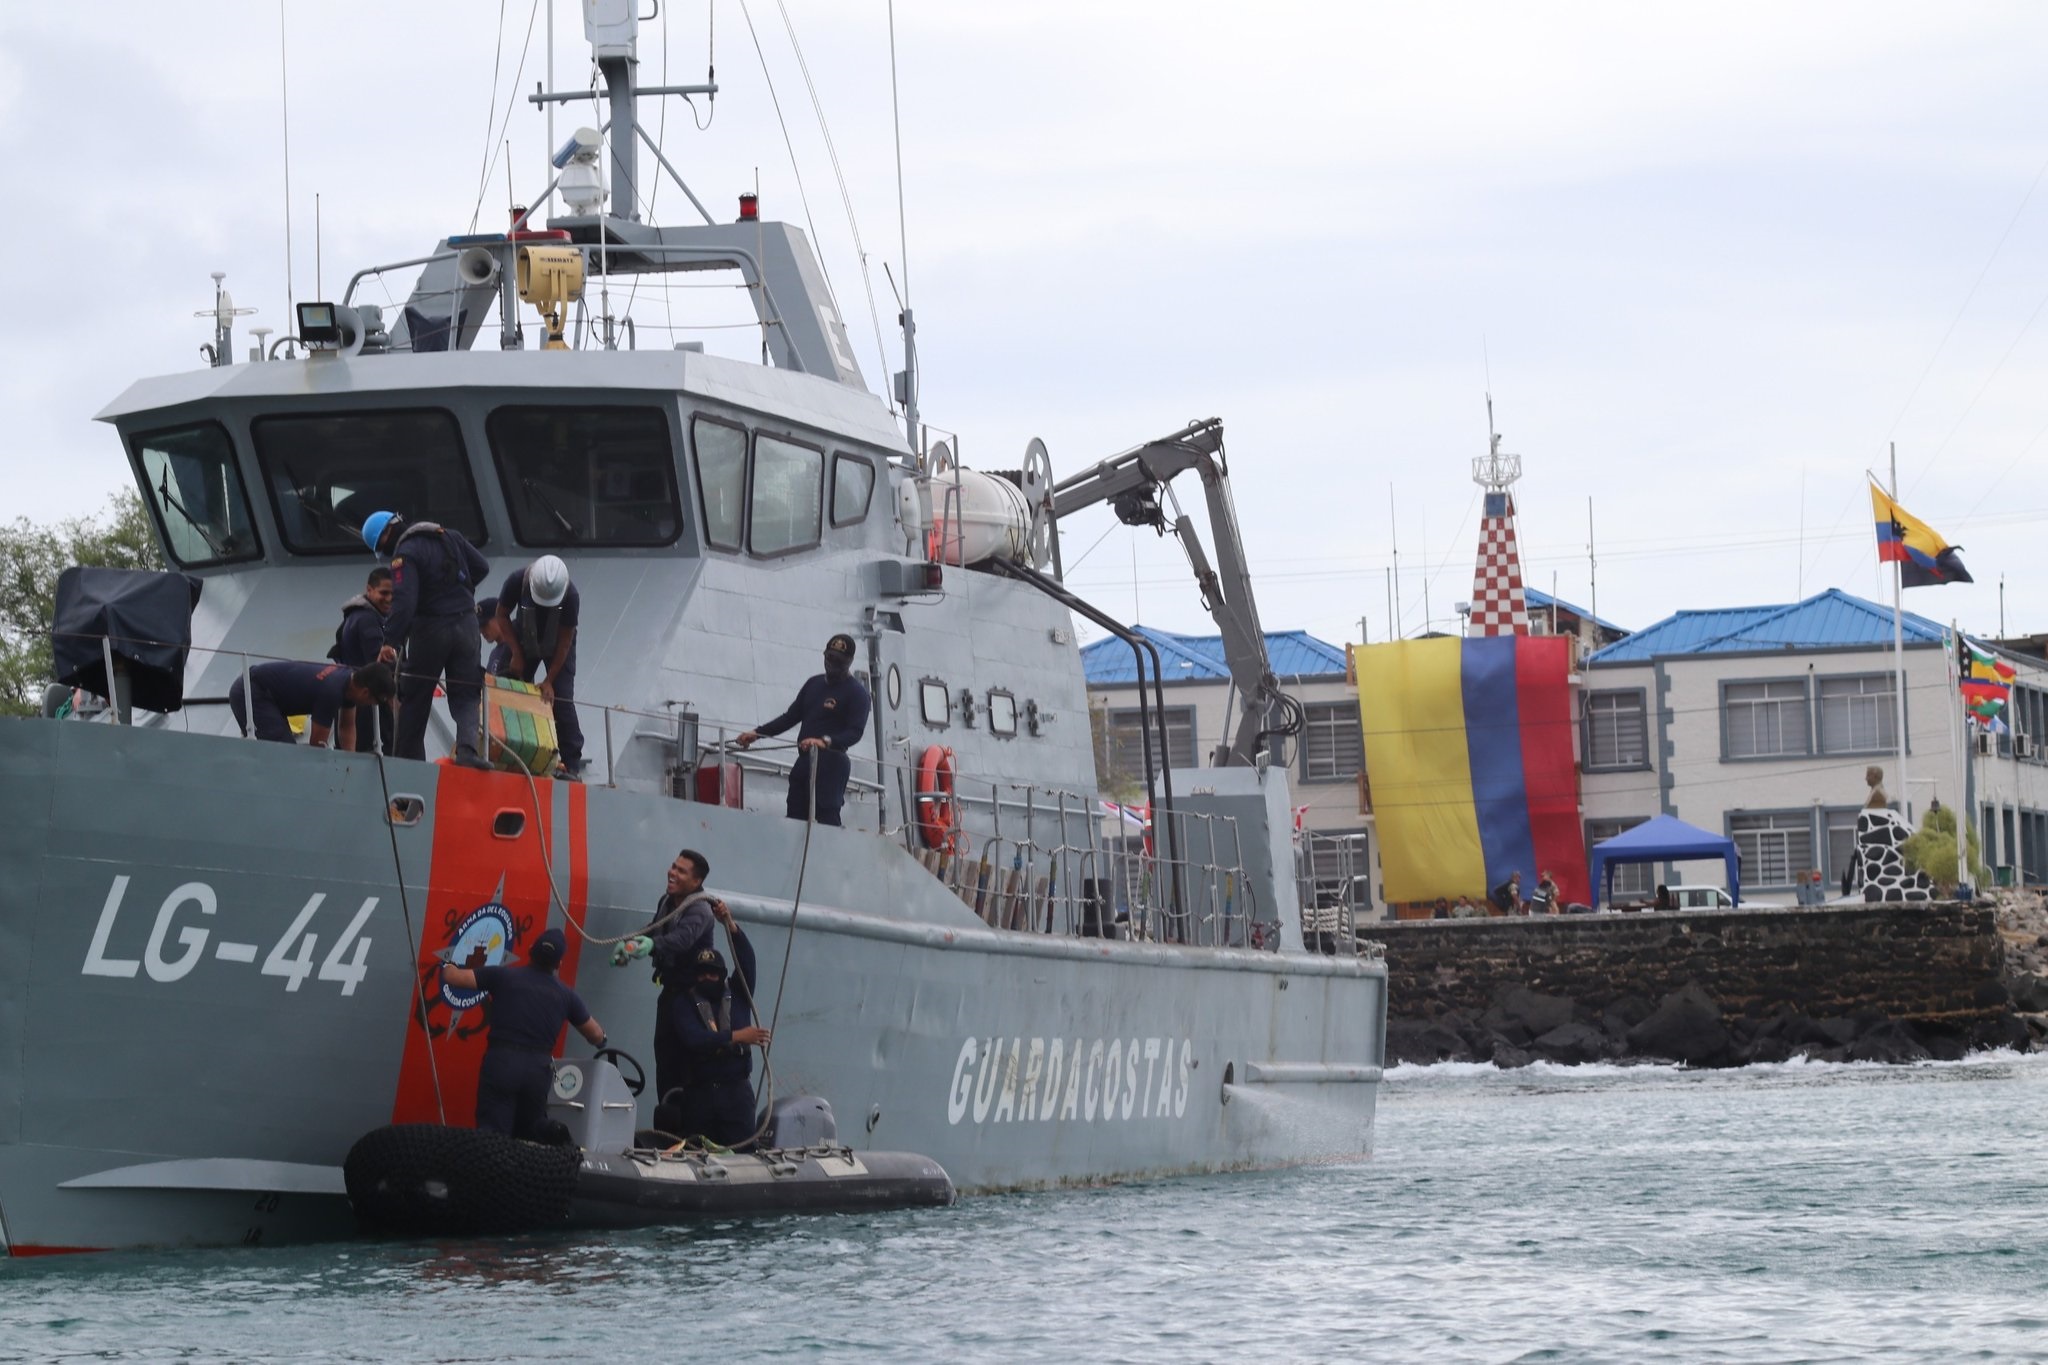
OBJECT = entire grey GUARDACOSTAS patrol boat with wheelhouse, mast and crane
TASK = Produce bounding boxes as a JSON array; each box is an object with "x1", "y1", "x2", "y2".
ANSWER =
[{"x1": 0, "y1": 0, "x2": 1386, "y2": 1254}]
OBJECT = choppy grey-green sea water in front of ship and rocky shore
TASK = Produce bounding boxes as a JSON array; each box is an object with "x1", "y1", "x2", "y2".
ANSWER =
[{"x1": 0, "y1": 1054, "x2": 2048, "y2": 1363}]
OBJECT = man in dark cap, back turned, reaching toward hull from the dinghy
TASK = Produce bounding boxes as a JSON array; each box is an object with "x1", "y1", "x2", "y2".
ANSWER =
[{"x1": 440, "y1": 929, "x2": 604, "y2": 1142}]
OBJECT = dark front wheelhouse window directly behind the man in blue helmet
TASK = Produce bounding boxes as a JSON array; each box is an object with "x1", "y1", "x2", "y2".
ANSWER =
[{"x1": 250, "y1": 407, "x2": 485, "y2": 555}]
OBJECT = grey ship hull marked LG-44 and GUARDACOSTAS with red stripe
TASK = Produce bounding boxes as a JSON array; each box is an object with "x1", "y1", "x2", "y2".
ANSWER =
[{"x1": 0, "y1": 720, "x2": 1386, "y2": 1254}]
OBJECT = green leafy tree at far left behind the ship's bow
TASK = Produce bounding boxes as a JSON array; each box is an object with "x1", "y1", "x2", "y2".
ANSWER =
[{"x1": 0, "y1": 489, "x2": 164, "y2": 716}]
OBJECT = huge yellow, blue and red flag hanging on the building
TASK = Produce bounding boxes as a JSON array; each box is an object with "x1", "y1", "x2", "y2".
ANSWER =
[{"x1": 1352, "y1": 634, "x2": 1589, "y2": 900}]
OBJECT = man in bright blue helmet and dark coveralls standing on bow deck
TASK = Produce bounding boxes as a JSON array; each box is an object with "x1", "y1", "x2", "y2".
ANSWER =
[{"x1": 362, "y1": 512, "x2": 492, "y2": 767}]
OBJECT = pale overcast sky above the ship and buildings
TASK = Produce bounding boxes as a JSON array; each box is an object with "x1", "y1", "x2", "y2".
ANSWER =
[{"x1": 0, "y1": 0, "x2": 2048, "y2": 654}]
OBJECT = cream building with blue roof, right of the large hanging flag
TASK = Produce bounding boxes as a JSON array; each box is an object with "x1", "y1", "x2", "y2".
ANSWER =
[{"x1": 1579, "y1": 587, "x2": 2048, "y2": 900}]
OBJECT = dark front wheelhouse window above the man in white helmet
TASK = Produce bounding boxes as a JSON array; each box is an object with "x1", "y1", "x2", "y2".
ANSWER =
[{"x1": 485, "y1": 407, "x2": 682, "y2": 546}]
